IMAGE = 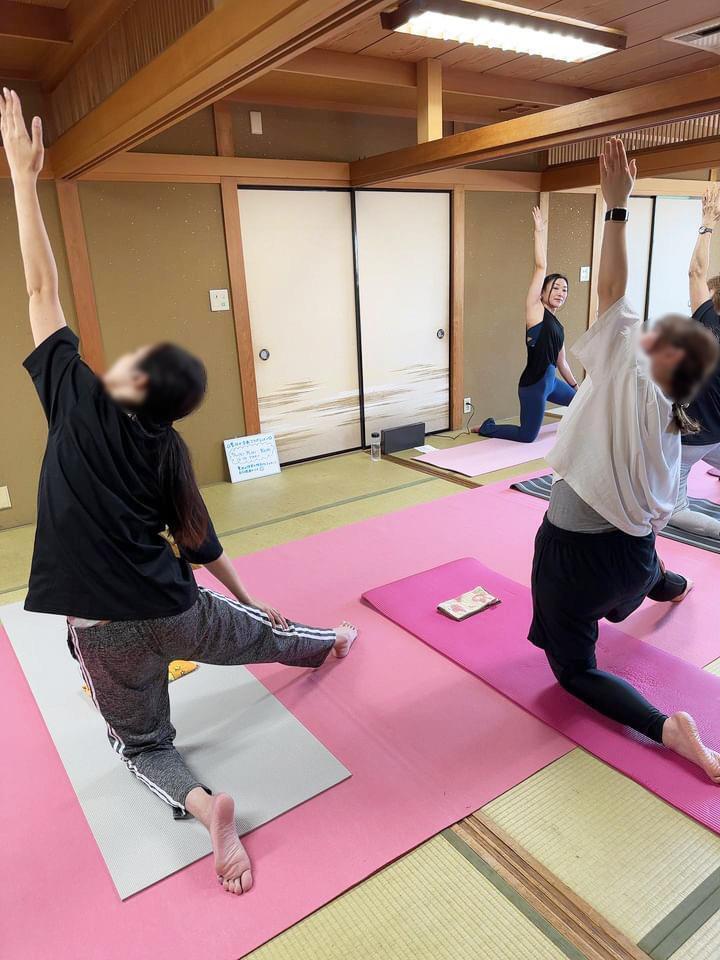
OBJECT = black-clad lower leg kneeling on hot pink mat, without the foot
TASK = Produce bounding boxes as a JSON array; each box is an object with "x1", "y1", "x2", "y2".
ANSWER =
[{"x1": 546, "y1": 653, "x2": 667, "y2": 743}]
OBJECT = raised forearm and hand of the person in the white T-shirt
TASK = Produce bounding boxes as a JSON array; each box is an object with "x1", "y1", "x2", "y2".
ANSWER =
[{"x1": 598, "y1": 137, "x2": 637, "y2": 316}]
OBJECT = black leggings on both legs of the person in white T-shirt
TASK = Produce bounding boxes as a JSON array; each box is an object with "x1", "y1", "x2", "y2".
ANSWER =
[{"x1": 545, "y1": 570, "x2": 687, "y2": 743}]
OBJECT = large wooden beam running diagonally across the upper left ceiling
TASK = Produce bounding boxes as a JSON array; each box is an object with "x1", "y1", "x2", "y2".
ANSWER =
[{"x1": 53, "y1": 0, "x2": 394, "y2": 178}]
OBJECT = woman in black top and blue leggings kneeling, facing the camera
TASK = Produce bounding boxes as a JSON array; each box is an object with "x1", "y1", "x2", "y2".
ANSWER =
[{"x1": 473, "y1": 207, "x2": 577, "y2": 443}]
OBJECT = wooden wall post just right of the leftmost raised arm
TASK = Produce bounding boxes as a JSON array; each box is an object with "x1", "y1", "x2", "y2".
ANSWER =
[{"x1": 56, "y1": 180, "x2": 105, "y2": 373}]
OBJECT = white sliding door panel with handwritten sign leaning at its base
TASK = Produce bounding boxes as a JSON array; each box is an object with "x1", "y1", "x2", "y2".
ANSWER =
[{"x1": 238, "y1": 188, "x2": 360, "y2": 463}]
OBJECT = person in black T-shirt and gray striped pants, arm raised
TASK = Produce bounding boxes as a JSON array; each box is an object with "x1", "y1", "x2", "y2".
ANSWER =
[{"x1": 0, "y1": 89, "x2": 357, "y2": 894}]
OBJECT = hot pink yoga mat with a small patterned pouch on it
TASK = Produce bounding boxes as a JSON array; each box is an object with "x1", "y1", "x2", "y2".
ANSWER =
[{"x1": 365, "y1": 557, "x2": 720, "y2": 833}]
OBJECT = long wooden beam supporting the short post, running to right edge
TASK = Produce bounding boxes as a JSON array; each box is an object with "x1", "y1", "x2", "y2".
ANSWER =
[{"x1": 350, "y1": 66, "x2": 720, "y2": 186}]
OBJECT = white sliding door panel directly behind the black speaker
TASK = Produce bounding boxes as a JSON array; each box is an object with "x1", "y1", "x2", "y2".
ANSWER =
[{"x1": 355, "y1": 190, "x2": 450, "y2": 439}]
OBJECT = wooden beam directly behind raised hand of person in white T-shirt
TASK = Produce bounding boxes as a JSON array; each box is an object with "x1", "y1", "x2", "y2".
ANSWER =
[{"x1": 540, "y1": 140, "x2": 720, "y2": 190}]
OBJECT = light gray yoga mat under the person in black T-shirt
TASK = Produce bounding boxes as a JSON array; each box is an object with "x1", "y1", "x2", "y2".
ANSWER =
[{"x1": 0, "y1": 603, "x2": 350, "y2": 900}]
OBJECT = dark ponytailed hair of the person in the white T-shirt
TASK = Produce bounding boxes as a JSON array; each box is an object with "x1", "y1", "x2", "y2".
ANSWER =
[{"x1": 655, "y1": 314, "x2": 720, "y2": 434}]
